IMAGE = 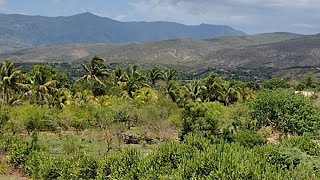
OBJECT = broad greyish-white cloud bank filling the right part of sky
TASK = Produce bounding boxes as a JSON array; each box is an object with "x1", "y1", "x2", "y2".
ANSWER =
[{"x1": 119, "y1": 0, "x2": 320, "y2": 34}]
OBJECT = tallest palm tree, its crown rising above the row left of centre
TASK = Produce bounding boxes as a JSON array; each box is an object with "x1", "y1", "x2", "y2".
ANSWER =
[{"x1": 78, "y1": 56, "x2": 109, "y2": 85}]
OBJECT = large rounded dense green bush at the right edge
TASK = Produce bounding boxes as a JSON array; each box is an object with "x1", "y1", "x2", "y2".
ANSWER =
[{"x1": 251, "y1": 89, "x2": 320, "y2": 135}]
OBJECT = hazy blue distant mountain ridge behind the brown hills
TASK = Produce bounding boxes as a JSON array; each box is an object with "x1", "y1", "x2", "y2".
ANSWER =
[{"x1": 0, "y1": 13, "x2": 244, "y2": 51}]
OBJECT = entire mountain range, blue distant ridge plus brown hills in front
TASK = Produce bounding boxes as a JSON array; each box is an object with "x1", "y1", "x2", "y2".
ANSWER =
[{"x1": 0, "y1": 13, "x2": 320, "y2": 78}]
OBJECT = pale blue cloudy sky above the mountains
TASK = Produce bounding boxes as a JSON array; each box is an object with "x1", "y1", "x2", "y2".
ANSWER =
[{"x1": 0, "y1": 0, "x2": 320, "y2": 34}]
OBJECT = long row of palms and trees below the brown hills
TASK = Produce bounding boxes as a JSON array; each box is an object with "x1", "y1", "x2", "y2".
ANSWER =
[{"x1": 0, "y1": 57, "x2": 255, "y2": 108}]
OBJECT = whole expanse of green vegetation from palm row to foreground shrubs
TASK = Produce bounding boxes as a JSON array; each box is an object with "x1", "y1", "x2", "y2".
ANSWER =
[{"x1": 0, "y1": 57, "x2": 320, "y2": 179}]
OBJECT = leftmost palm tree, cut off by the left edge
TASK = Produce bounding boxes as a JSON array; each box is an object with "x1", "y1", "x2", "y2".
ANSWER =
[{"x1": 0, "y1": 61, "x2": 28, "y2": 104}]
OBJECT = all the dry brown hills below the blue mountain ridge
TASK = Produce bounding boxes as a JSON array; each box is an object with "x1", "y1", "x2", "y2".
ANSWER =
[{"x1": 0, "y1": 33, "x2": 320, "y2": 76}]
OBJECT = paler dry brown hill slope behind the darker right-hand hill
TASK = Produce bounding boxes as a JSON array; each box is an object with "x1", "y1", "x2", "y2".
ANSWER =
[{"x1": 0, "y1": 33, "x2": 303, "y2": 64}]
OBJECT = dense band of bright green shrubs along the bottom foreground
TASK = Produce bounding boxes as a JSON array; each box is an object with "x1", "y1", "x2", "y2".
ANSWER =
[{"x1": 5, "y1": 135, "x2": 320, "y2": 179}]
